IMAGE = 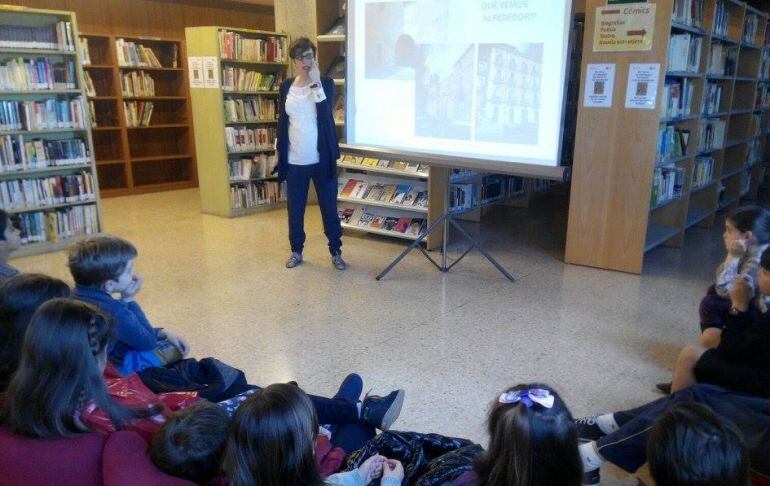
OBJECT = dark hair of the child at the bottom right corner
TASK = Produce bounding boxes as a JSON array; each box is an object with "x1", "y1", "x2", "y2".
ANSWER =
[{"x1": 647, "y1": 402, "x2": 749, "y2": 486}]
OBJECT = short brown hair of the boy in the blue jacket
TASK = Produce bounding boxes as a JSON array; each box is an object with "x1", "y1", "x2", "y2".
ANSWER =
[{"x1": 68, "y1": 236, "x2": 137, "y2": 287}]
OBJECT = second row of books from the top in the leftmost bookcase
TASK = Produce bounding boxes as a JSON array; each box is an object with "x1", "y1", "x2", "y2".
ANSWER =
[{"x1": 0, "y1": 57, "x2": 77, "y2": 91}]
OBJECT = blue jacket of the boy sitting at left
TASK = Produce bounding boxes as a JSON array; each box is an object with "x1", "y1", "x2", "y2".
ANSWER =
[{"x1": 72, "y1": 285, "x2": 158, "y2": 362}]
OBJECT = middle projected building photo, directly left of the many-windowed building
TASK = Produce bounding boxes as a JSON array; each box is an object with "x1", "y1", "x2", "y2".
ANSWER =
[{"x1": 414, "y1": 44, "x2": 476, "y2": 140}]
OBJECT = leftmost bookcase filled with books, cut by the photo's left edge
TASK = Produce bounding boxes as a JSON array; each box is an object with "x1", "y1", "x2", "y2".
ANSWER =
[{"x1": 0, "y1": 5, "x2": 102, "y2": 258}]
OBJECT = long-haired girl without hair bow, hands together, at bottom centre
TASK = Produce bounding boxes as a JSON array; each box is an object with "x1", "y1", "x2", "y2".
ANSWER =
[{"x1": 223, "y1": 383, "x2": 404, "y2": 486}]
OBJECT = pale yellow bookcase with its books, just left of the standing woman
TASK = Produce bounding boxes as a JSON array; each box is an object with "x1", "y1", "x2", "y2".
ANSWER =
[{"x1": 186, "y1": 27, "x2": 289, "y2": 217}]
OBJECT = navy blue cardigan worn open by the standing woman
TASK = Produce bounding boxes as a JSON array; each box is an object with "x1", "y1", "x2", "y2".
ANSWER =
[{"x1": 276, "y1": 76, "x2": 340, "y2": 181}]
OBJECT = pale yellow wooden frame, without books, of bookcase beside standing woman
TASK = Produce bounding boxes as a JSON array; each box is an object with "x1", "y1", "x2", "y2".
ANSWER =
[{"x1": 186, "y1": 27, "x2": 289, "y2": 217}]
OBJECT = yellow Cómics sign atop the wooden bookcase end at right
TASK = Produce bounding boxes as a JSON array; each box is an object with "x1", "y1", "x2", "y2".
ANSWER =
[{"x1": 594, "y1": 2, "x2": 656, "y2": 52}]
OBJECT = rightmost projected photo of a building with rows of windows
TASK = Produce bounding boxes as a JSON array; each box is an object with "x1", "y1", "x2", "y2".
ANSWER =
[{"x1": 475, "y1": 44, "x2": 543, "y2": 145}]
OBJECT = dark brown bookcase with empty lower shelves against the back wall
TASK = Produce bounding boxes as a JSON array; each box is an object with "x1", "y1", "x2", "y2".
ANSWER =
[{"x1": 80, "y1": 34, "x2": 197, "y2": 197}]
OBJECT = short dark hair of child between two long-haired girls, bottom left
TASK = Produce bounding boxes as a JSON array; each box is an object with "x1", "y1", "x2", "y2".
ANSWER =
[{"x1": 150, "y1": 401, "x2": 229, "y2": 483}]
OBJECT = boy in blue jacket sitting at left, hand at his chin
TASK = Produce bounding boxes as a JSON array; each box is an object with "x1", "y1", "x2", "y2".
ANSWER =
[{"x1": 69, "y1": 236, "x2": 190, "y2": 375}]
